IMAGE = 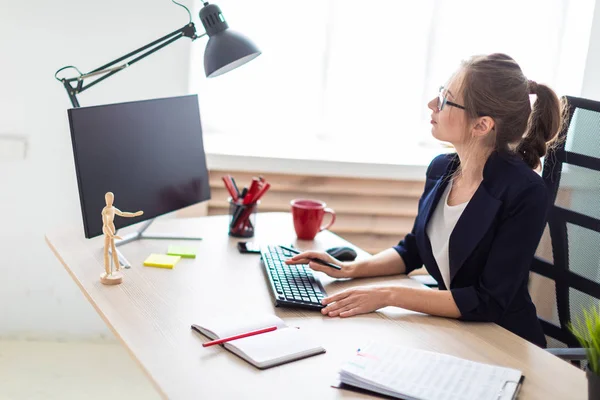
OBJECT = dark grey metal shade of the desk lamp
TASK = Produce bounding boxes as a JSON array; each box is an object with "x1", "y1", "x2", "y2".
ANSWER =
[{"x1": 200, "y1": 3, "x2": 261, "y2": 78}]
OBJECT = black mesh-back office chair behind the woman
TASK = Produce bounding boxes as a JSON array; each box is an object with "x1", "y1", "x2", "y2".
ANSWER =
[{"x1": 530, "y1": 96, "x2": 600, "y2": 360}]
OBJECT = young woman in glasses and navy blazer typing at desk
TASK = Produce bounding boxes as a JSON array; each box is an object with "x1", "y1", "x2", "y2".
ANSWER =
[{"x1": 287, "y1": 54, "x2": 562, "y2": 347}]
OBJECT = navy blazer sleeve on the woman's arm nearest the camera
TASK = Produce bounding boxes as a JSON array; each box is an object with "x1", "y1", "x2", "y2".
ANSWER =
[{"x1": 450, "y1": 183, "x2": 550, "y2": 322}]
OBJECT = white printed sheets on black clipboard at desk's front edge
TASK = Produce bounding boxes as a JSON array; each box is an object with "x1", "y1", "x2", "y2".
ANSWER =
[{"x1": 336, "y1": 343, "x2": 524, "y2": 400}]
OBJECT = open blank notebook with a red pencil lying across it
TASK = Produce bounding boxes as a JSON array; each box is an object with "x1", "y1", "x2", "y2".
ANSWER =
[{"x1": 192, "y1": 314, "x2": 325, "y2": 369}]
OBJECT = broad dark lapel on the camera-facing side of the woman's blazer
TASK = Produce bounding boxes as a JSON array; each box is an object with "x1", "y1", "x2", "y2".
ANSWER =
[{"x1": 449, "y1": 184, "x2": 502, "y2": 281}]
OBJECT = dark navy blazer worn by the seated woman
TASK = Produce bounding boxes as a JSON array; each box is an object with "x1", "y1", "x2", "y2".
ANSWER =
[{"x1": 394, "y1": 152, "x2": 551, "y2": 347}]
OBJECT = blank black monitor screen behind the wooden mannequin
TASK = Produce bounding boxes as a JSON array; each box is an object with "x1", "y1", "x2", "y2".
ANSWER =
[{"x1": 68, "y1": 95, "x2": 210, "y2": 238}]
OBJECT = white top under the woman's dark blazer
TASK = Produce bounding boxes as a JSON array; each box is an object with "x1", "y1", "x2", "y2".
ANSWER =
[{"x1": 427, "y1": 181, "x2": 469, "y2": 289}]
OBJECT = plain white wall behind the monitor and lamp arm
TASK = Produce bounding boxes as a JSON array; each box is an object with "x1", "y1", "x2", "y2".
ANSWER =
[{"x1": 0, "y1": 0, "x2": 193, "y2": 338}]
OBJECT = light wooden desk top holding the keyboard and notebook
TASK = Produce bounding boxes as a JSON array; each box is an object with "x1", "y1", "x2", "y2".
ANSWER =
[{"x1": 46, "y1": 213, "x2": 587, "y2": 400}]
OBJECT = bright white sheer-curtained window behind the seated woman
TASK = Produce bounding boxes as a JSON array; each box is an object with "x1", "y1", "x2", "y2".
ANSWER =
[{"x1": 190, "y1": 0, "x2": 594, "y2": 161}]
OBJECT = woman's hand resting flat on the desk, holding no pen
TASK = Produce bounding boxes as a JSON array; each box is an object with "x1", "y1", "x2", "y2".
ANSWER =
[{"x1": 321, "y1": 287, "x2": 390, "y2": 317}]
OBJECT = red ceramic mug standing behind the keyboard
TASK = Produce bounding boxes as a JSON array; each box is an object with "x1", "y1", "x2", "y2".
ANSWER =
[{"x1": 290, "y1": 199, "x2": 335, "y2": 240}]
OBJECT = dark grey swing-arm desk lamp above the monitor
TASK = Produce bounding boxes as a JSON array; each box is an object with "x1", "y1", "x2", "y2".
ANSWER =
[{"x1": 54, "y1": 0, "x2": 261, "y2": 107}]
